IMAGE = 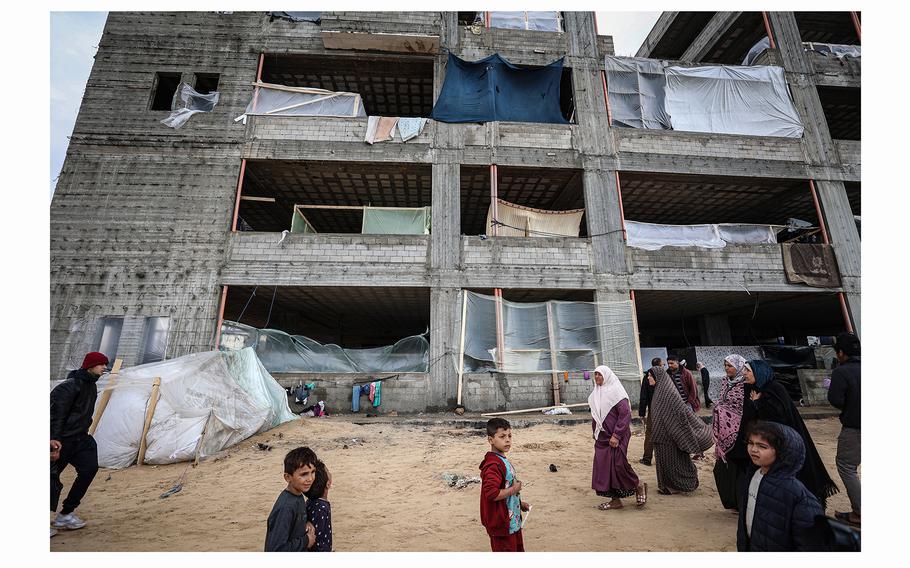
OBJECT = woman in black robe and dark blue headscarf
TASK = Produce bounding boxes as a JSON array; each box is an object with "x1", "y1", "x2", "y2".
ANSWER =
[{"x1": 743, "y1": 359, "x2": 840, "y2": 509}]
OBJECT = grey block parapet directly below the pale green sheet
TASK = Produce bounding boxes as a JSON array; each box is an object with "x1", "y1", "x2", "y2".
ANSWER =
[{"x1": 221, "y1": 232, "x2": 430, "y2": 286}]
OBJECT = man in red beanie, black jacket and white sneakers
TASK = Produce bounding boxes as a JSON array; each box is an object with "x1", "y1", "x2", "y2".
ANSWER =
[{"x1": 51, "y1": 351, "x2": 108, "y2": 536}]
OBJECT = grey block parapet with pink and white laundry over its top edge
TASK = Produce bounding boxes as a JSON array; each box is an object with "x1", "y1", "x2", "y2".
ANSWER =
[{"x1": 243, "y1": 115, "x2": 436, "y2": 163}]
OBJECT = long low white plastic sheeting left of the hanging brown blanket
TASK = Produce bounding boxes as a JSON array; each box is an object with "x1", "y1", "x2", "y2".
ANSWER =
[{"x1": 625, "y1": 221, "x2": 781, "y2": 250}]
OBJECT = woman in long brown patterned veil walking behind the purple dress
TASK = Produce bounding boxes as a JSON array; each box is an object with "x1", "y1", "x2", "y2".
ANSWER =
[{"x1": 651, "y1": 367, "x2": 713, "y2": 495}]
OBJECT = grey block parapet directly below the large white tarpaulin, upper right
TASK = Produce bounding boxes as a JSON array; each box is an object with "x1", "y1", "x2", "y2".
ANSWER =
[{"x1": 610, "y1": 127, "x2": 806, "y2": 178}]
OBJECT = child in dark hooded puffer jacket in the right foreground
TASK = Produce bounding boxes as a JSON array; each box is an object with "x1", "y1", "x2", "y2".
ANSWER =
[{"x1": 736, "y1": 421, "x2": 825, "y2": 552}]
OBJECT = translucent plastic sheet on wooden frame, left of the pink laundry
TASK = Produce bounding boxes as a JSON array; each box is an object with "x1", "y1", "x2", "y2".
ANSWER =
[{"x1": 234, "y1": 83, "x2": 367, "y2": 122}]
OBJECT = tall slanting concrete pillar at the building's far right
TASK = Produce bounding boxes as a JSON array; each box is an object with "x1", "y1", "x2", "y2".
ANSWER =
[{"x1": 768, "y1": 12, "x2": 861, "y2": 335}]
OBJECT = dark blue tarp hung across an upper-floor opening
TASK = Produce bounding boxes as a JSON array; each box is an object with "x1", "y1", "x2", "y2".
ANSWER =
[{"x1": 430, "y1": 53, "x2": 569, "y2": 124}]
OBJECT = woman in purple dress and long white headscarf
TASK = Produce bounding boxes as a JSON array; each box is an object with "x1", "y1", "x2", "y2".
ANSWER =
[{"x1": 588, "y1": 365, "x2": 648, "y2": 511}]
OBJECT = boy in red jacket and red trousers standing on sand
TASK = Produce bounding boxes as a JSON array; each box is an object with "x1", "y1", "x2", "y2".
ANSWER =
[{"x1": 480, "y1": 418, "x2": 530, "y2": 552}]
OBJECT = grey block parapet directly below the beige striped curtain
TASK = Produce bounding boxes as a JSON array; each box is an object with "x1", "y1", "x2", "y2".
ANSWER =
[{"x1": 461, "y1": 236, "x2": 594, "y2": 289}]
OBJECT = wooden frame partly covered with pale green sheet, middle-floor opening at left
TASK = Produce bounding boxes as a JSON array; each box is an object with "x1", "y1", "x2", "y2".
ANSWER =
[{"x1": 291, "y1": 205, "x2": 432, "y2": 235}]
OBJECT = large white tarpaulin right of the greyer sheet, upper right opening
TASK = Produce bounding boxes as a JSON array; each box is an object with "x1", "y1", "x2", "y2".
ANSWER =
[{"x1": 664, "y1": 65, "x2": 803, "y2": 138}]
